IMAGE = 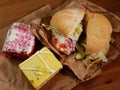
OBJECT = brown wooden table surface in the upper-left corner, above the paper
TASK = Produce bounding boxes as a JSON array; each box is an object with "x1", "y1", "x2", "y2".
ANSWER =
[{"x1": 0, "y1": 0, "x2": 64, "y2": 28}]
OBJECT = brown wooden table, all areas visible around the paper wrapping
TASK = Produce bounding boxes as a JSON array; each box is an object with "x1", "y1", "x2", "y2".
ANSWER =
[{"x1": 0, "y1": 0, "x2": 120, "y2": 90}]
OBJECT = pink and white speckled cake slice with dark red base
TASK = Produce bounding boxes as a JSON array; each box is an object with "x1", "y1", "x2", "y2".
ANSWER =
[{"x1": 2, "y1": 23, "x2": 35, "y2": 58}]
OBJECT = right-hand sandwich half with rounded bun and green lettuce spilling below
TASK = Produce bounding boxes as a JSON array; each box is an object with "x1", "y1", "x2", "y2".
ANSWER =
[{"x1": 76, "y1": 12, "x2": 112, "y2": 67}]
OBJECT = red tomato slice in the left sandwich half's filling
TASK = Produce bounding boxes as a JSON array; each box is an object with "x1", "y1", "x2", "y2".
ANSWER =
[{"x1": 52, "y1": 37, "x2": 67, "y2": 54}]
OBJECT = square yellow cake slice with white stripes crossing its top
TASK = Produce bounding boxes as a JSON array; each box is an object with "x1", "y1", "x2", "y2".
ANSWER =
[{"x1": 19, "y1": 47, "x2": 62, "y2": 89}]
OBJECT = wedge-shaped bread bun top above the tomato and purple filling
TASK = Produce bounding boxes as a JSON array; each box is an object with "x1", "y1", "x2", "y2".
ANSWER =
[{"x1": 50, "y1": 8, "x2": 85, "y2": 37}]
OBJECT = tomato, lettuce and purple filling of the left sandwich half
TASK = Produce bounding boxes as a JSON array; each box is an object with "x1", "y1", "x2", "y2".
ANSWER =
[{"x1": 42, "y1": 24, "x2": 82, "y2": 55}]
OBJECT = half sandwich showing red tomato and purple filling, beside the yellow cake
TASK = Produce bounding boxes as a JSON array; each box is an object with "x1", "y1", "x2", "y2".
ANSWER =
[{"x1": 42, "y1": 8, "x2": 85, "y2": 55}]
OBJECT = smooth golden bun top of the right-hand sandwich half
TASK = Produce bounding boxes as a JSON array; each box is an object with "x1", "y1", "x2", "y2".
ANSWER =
[{"x1": 86, "y1": 13, "x2": 112, "y2": 52}]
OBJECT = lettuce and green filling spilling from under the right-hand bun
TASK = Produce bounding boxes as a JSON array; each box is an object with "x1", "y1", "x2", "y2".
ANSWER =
[{"x1": 75, "y1": 37, "x2": 110, "y2": 68}]
